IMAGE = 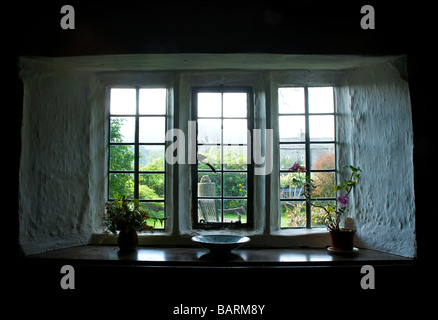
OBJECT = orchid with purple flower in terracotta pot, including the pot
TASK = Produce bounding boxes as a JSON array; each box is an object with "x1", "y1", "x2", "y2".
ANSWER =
[{"x1": 289, "y1": 162, "x2": 362, "y2": 252}]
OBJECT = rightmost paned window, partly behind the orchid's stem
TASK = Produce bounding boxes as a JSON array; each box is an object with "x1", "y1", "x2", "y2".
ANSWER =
[{"x1": 278, "y1": 87, "x2": 336, "y2": 228}]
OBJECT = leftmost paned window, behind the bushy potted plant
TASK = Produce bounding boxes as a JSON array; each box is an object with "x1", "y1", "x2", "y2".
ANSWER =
[{"x1": 108, "y1": 88, "x2": 167, "y2": 227}]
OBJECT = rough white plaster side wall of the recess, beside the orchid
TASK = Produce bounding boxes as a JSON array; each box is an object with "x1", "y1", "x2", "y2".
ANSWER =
[{"x1": 337, "y1": 59, "x2": 416, "y2": 257}]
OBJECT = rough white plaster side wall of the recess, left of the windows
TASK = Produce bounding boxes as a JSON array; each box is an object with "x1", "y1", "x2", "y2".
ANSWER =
[{"x1": 19, "y1": 59, "x2": 104, "y2": 254}]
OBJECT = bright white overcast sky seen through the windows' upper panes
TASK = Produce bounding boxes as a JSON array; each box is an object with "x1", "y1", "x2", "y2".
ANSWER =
[{"x1": 110, "y1": 87, "x2": 334, "y2": 143}]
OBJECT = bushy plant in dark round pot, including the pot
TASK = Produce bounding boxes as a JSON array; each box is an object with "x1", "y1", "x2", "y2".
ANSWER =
[{"x1": 103, "y1": 196, "x2": 165, "y2": 251}]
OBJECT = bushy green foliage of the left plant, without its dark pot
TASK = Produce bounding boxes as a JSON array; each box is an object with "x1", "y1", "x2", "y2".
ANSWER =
[{"x1": 102, "y1": 195, "x2": 166, "y2": 233}]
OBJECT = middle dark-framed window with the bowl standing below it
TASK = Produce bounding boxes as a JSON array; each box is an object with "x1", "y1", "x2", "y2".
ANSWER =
[{"x1": 192, "y1": 87, "x2": 253, "y2": 228}]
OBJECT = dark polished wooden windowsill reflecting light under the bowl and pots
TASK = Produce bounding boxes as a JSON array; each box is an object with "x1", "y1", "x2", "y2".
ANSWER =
[{"x1": 27, "y1": 245, "x2": 414, "y2": 268}]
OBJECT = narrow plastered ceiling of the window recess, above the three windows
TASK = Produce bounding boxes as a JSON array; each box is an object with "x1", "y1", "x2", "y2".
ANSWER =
[{"x1": 46, "y1": 53, "x2": 393, "y2": 71}]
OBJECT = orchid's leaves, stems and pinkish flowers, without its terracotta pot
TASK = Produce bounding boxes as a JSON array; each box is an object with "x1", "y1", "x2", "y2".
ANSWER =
[{"x1": 289, "y1": 162, "x2": 362, "y2": 231}]
